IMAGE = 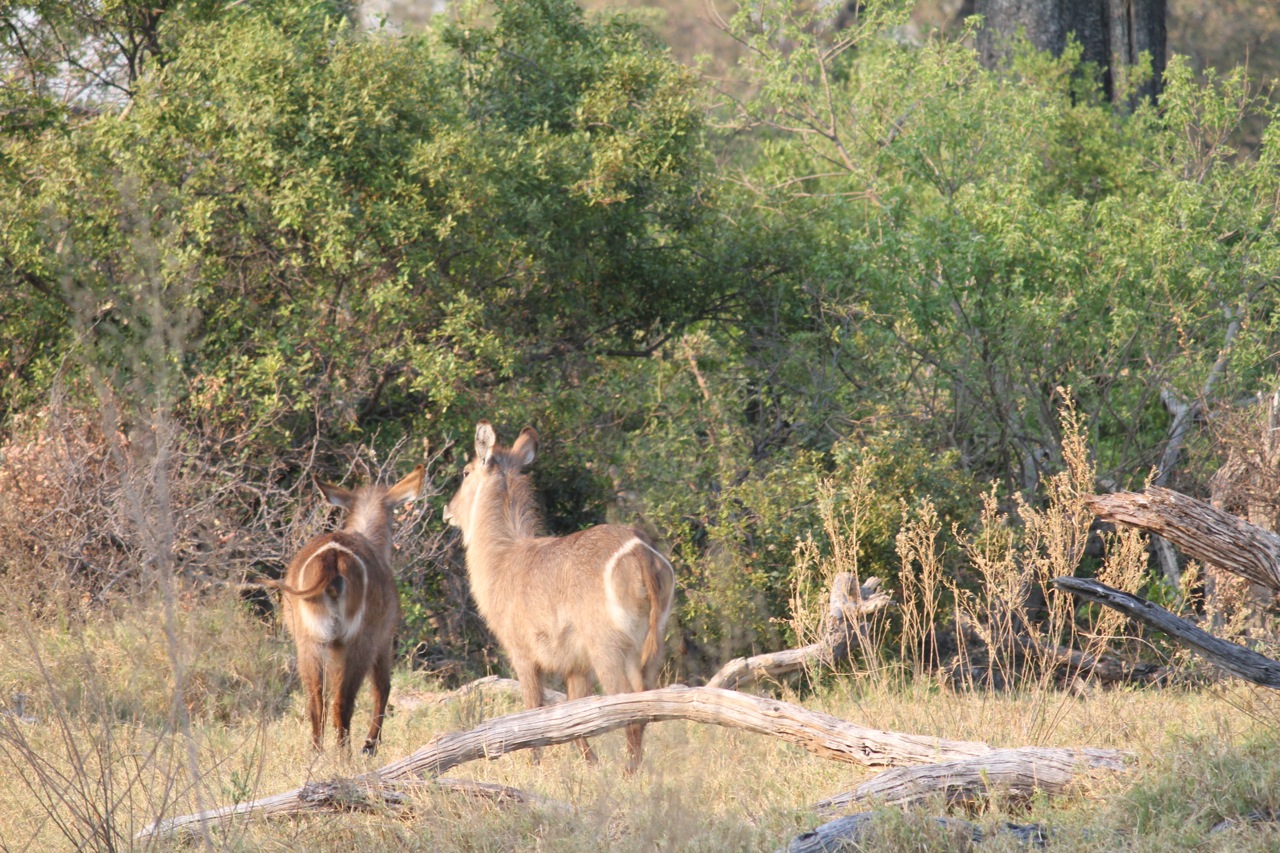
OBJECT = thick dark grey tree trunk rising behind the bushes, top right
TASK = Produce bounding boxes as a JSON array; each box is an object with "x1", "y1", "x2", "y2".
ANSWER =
[{"x1": 974, "y1": 0, "x2": 1167, "y2": 106}]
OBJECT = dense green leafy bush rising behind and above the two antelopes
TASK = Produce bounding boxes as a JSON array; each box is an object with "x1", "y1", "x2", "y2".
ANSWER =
[{"x1": 4, "y1": 3, "x2": 703, "y2": 448}]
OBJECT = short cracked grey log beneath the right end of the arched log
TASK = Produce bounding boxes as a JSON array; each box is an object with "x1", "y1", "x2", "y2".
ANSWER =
[{"x1": 817, "y1": 747, "x2": 1129, "y2": 815}]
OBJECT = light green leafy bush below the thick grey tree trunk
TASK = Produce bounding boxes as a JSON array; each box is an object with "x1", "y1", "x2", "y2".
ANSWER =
[{"x1": 716, "y1": 4, "x2": 1277, "y2": 504}]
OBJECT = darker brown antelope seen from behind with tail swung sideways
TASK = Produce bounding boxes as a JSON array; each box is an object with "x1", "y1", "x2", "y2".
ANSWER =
[{"x1": 273, "y1": 465, "x2": 425, "y2": 754}]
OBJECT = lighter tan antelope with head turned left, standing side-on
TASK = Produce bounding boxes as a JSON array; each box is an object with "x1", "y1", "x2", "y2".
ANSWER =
[{"x1": 444, "y1": 420, "x2": 676, "y2": 771}]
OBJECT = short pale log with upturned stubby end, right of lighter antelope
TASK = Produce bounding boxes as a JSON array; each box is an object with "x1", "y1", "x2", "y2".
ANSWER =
[{"x1": 707, "y1": 571, "x2": 893, "y2": 690}]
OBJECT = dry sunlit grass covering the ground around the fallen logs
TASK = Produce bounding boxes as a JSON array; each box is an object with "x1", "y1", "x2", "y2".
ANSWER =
[{"x1": 0, "y1": 589, "x2": 1280, "y2": 850}]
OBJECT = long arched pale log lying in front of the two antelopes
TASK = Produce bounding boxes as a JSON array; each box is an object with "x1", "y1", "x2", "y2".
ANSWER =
[{"x1": 138, "y1": 686, "x2": 992, "y2": 839}]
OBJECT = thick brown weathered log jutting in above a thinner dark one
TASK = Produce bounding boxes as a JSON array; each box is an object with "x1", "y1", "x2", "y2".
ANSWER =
[{"x1": 1084, "y1": 485, "x2": 1280, "y2": 590}]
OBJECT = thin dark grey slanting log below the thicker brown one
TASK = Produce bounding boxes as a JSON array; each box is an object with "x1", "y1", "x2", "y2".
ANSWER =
[{"x1": 1052, "y1": 578, "x2": 1280, "y2": 689}]
